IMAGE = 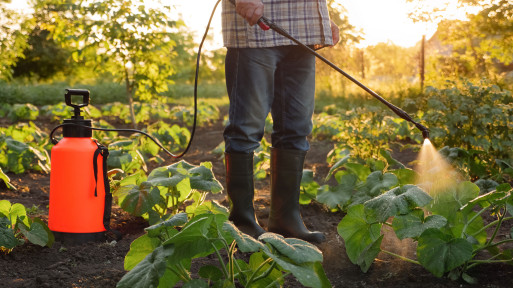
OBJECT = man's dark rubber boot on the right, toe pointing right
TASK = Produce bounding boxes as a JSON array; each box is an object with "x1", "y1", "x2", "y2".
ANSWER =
[{"x1": 267, "y1": 148, "x2": 326, "y2": 244}]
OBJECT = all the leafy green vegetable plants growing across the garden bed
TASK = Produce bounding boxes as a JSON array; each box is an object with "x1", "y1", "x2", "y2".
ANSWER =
[{"x1": 0, "y1": 82, "x2": 513, "y2": 287}]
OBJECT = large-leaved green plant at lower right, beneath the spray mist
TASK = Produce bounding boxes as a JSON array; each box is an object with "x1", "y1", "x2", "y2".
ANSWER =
[{"x1": 338, "y1": 171, "x2": 513, "y2": 282}]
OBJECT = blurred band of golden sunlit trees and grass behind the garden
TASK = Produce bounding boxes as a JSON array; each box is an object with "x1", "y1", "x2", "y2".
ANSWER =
[{"x1": 0, "y1": 0, "x2": 513, "y2": 110}]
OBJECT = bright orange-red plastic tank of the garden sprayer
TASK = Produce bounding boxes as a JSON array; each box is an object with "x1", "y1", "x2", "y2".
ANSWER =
[{"x1": 48, "y1": 137, "x2": 105, "y2": 233}]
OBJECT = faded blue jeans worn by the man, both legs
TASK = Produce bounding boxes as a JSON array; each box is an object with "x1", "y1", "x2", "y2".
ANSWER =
[{"x1": 224, "y1": 46, "x2": 315, "y2": 153}]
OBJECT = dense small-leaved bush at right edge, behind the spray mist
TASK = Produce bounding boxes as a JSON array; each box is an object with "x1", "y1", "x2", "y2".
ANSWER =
[{"x1": 420, "y1": 82, "x2": 513, "y2": 177}]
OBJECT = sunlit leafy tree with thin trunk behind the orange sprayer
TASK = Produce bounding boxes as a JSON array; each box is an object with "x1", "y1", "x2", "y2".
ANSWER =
[{"x1": 37, "y1": 0, "x2": 183, "y2": 127}]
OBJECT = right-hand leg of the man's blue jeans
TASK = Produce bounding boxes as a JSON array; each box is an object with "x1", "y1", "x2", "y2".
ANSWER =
[{"x1": 271, "y1": 46, "x2": 315, "y2": 151}]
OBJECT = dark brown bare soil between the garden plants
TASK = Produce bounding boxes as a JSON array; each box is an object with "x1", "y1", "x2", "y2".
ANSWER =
[{"x1": 0, "y1": 114, "x2": 513, "y2": 288}]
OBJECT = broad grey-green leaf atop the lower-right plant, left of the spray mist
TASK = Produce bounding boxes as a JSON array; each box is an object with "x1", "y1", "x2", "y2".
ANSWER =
[{"x1": 364, "y1": 185, "x2": 432, "y2": 222}]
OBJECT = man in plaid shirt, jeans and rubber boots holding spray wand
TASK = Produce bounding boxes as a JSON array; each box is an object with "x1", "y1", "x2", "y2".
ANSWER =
[{"x1": 222, "y1": 0, "x2": 339, "y2": 243}]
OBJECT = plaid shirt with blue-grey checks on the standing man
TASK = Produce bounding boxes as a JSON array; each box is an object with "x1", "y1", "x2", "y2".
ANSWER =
[{"x1": 222, "y1": 0, "x2": 333, "y2": 48}]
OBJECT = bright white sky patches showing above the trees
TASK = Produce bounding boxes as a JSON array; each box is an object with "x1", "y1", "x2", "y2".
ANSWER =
[{"x1": 8, "y1": 0, "x2": 476, "y2": 49}]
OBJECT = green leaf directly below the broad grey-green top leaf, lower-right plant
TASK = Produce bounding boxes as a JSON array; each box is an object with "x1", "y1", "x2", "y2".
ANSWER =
[{"x1": 392, "y1": 209, "x2": 447, "y2": 240}]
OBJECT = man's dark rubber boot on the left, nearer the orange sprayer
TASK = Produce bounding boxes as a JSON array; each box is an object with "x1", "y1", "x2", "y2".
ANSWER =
[{"x1": 224, "y1": 153, "x2": 265, "y2": 238}]
